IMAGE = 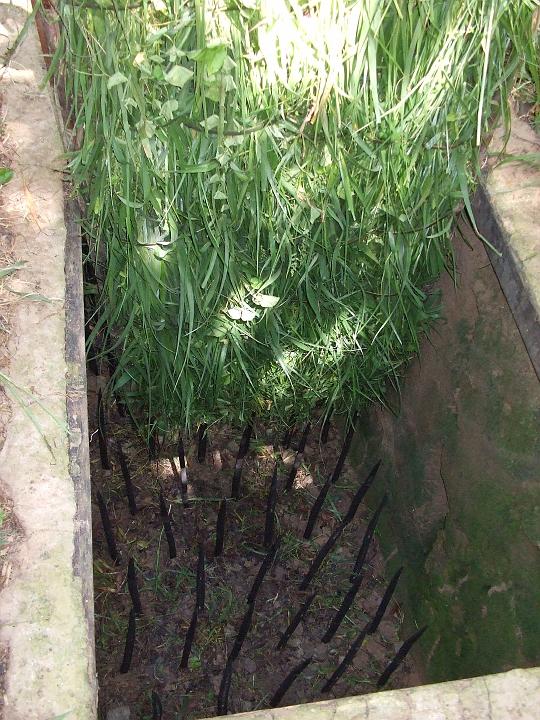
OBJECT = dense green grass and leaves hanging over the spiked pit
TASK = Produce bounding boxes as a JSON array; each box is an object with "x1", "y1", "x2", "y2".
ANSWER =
[{"x1": 57, "y1": 0, "x2": 536, "y2": 428}]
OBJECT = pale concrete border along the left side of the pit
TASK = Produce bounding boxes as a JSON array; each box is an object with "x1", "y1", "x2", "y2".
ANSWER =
[{"x1": 0, "y1": 0, "x2": 97, "y2": 720}]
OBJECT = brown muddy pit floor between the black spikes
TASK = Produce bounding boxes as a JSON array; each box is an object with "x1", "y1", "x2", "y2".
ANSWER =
[{"x1": 89, "y1": 375, "x2": 414, "y2": 720}]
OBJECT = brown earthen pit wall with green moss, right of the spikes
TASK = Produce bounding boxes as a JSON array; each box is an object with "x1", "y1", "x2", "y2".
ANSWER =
[{"x1": 356, "y1": 222, "x2": 540, "y2": 682}]
